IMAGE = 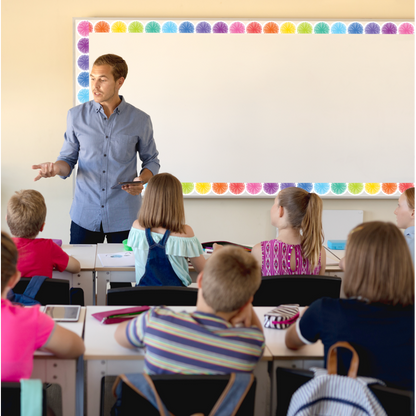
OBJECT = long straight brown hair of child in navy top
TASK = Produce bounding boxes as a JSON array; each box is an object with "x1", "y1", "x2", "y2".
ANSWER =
[{"x1": 342, "y1": 221, "x2": 416, "y2": 305}]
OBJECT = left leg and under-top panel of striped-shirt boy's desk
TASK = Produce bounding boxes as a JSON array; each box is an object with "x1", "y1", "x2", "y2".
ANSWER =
[{"x1": 85, "y1": 360, "x2": 144, "y2": 416}]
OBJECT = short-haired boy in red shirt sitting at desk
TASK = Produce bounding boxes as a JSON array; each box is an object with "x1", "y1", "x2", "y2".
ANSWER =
[{"x1": 6, "y1": 189, "x2": 81, "y2": 277}]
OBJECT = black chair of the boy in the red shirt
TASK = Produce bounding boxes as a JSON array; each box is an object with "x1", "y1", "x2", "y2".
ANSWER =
[{"x1": 13, "y1": 277, "x2": 70, "y2": 305}]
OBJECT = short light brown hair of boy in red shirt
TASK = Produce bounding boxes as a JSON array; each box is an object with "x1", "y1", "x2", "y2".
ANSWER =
[{"x1": 7, "y1": 189, "x2": 46, "y2": 238}]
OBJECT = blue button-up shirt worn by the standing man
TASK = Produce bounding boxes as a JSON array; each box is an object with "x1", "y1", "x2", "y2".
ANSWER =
[{"x1": 58, "y1": 96, "x2": 160, "y2": 233}]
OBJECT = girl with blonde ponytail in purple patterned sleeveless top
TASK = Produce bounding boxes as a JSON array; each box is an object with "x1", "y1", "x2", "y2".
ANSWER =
[{"x1": 252, "y1": 187, "x2": 326, "y2": 276}]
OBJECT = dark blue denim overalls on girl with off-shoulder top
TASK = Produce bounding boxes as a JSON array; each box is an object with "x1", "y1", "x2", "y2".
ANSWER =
[{"x1": 138, "y1": 228, "x2": 183, "y2": 286}]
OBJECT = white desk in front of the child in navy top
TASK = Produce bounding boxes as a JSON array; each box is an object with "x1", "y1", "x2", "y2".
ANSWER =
[{"x1": 254, "y1": 306, "x2": 324, "y2": 416}]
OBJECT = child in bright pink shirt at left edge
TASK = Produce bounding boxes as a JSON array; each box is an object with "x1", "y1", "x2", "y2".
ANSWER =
[{"x1": 0, "y1": 232, "x2": 84, "y2": 382}]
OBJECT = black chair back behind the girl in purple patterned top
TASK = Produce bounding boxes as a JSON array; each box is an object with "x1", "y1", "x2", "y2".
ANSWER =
[{"x1": 253, "y1": 275, "x2": 341, "y2": 306}]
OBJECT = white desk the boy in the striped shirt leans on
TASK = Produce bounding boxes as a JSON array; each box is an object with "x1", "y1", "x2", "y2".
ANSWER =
[{"x1": 84, "y1": 306, "x2": 272, "y2": 416}]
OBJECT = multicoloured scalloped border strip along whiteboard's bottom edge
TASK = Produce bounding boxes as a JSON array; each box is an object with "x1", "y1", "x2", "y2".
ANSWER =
[{"x1": 182, "y1": 182, "x2": 416, "y2": 197}]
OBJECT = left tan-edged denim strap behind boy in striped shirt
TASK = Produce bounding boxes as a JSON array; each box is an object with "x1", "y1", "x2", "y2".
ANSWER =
[{"x1": 113, "y1": 374, "x2": 173, "y2": 416}]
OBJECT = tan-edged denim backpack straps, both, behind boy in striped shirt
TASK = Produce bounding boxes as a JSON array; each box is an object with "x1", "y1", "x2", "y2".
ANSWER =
[{"x1": 111, "y1": 373, "x2": 254, "y2": 416}]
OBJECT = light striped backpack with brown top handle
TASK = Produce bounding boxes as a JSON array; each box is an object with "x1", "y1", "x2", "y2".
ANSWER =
[{"x1": 287, "y1": 342, "x2": 387, "y2": 416}]
